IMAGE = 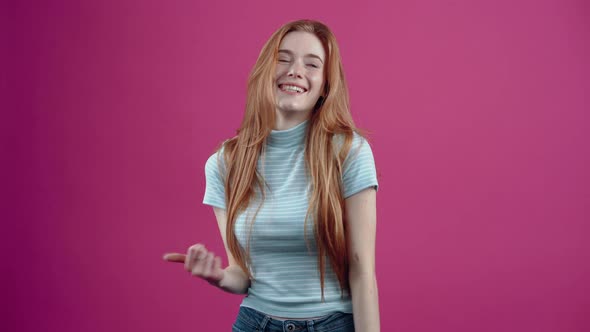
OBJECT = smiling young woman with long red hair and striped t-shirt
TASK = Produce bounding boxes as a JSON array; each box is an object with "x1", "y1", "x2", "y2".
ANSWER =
[{"x1": 164, "y1": 20, "x2": 379, "y2": 332}]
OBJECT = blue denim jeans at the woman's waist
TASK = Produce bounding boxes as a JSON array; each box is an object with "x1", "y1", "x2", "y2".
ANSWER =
[{"x1": 232, "y1": 307, "x2": 354, "y2": 332}]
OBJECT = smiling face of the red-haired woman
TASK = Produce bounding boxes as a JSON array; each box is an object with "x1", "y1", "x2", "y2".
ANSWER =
[{"x1": 275, "y1": 31, "x2": 326, "y2": 113}]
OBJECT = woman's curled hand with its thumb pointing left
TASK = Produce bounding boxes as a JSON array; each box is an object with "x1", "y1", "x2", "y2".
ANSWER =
[{"x1": 163, "y1": 243, "x2": 225, "y2": 287}]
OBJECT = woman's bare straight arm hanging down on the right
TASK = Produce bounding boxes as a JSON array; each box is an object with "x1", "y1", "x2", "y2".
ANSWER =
[{"x1": 344, "y1": 188, "x2": 380, "y2": 332}]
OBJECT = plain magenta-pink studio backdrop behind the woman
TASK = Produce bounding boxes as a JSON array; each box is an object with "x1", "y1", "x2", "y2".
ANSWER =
[{"x1": 2, "y1": 0, "x2": 590, "y2": 332}]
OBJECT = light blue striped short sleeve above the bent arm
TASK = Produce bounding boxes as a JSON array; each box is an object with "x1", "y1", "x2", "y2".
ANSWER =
[{"x1": 203, "y1": 150, "x2": 225, "y2": 209}]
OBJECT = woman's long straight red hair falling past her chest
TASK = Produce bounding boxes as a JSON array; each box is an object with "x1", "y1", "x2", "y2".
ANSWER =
[{"x1": 223, "y1": 20, "x2": 356, "y2": 299}]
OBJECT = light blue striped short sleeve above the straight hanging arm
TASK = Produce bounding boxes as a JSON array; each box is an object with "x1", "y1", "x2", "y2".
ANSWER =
[{"x1": 342, "y1": 133, "x2": 379, "y2": 198}]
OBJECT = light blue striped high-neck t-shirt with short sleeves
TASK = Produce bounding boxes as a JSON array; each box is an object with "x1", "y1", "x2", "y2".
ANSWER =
[{"x1": 203, "y1": 120, "x2": 378, "y2": 318}]
